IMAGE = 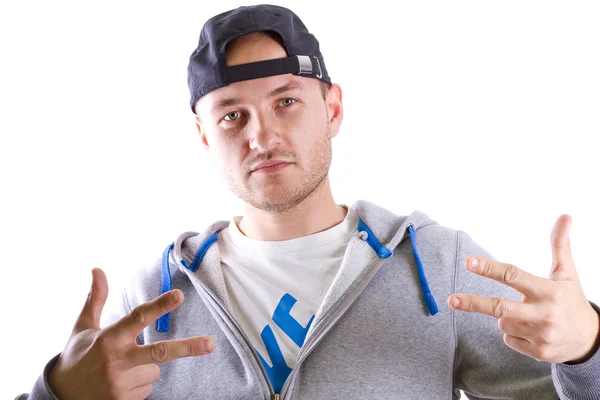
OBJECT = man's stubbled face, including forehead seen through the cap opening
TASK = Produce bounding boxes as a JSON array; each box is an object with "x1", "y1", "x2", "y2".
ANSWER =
[{"x1": 196, "y1": 34, "x2": 342, "y2": 212}]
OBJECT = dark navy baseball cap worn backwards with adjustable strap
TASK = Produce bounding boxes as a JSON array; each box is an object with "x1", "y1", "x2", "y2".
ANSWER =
[{"x1": 188, "y1": 4, "x2": 331, "y2": 113}]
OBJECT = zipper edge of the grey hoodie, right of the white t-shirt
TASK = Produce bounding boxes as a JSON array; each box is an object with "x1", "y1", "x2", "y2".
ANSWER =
[{"x1": 274, "y1": 257, "x2": 386, "y2": 400}]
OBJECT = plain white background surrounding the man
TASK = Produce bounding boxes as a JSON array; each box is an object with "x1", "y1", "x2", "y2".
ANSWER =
[{"x1": 0, "y1": 0, "x2": 600, "y2": 399}]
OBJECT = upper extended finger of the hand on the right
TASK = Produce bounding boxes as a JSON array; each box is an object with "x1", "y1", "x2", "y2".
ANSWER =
[{"x1": 466, "y1": 256, "x2": 554, "y2": 298}]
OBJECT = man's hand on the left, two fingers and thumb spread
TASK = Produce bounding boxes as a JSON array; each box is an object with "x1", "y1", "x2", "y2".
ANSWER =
[{"x1": 49, "y1": 268, "x2": 214, "y2": 400}]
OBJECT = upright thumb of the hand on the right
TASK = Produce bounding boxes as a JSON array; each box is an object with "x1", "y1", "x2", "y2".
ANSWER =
[{"x1": 550, "y1": 214, "x2": 578, "y2": 281}]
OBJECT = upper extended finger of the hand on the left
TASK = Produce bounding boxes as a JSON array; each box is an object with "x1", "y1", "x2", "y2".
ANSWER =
[{"x1": 108, "y1": 289, "x2": 183, "y2": 339}]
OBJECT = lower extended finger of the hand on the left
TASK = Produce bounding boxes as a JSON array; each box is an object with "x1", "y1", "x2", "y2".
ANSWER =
[{"x1": 128, "y1": 336, "x2": 214, "y2": 365}]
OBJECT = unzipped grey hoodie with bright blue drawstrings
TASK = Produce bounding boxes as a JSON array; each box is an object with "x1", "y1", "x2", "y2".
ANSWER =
[{"x1": 17, "y1": 201, "x2": 600, "y2": 400}]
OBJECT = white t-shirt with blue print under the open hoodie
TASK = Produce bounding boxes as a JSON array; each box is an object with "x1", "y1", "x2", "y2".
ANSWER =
[{"x1": 218, "y1": 206, "x2": 358, "y2": 393}]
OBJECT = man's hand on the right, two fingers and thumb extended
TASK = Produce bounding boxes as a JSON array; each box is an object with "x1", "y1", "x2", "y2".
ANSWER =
[{"x1": 448, "y1": 214, "x2": 600, "y2": 364}]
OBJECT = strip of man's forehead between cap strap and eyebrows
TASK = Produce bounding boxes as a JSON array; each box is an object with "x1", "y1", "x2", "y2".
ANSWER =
[{"x1": 196, "y1": 74, "x2": 319, "y2": 115}]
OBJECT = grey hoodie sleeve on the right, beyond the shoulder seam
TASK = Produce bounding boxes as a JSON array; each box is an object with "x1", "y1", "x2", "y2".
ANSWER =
[{"x1": 452, "y1": 231, "x2": 600, "y2": 400}]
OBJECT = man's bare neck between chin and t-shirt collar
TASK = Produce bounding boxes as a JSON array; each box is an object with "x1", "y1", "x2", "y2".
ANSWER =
[{"x1": 238, "y1": 177, "x2": 347, "y2": 241}]
